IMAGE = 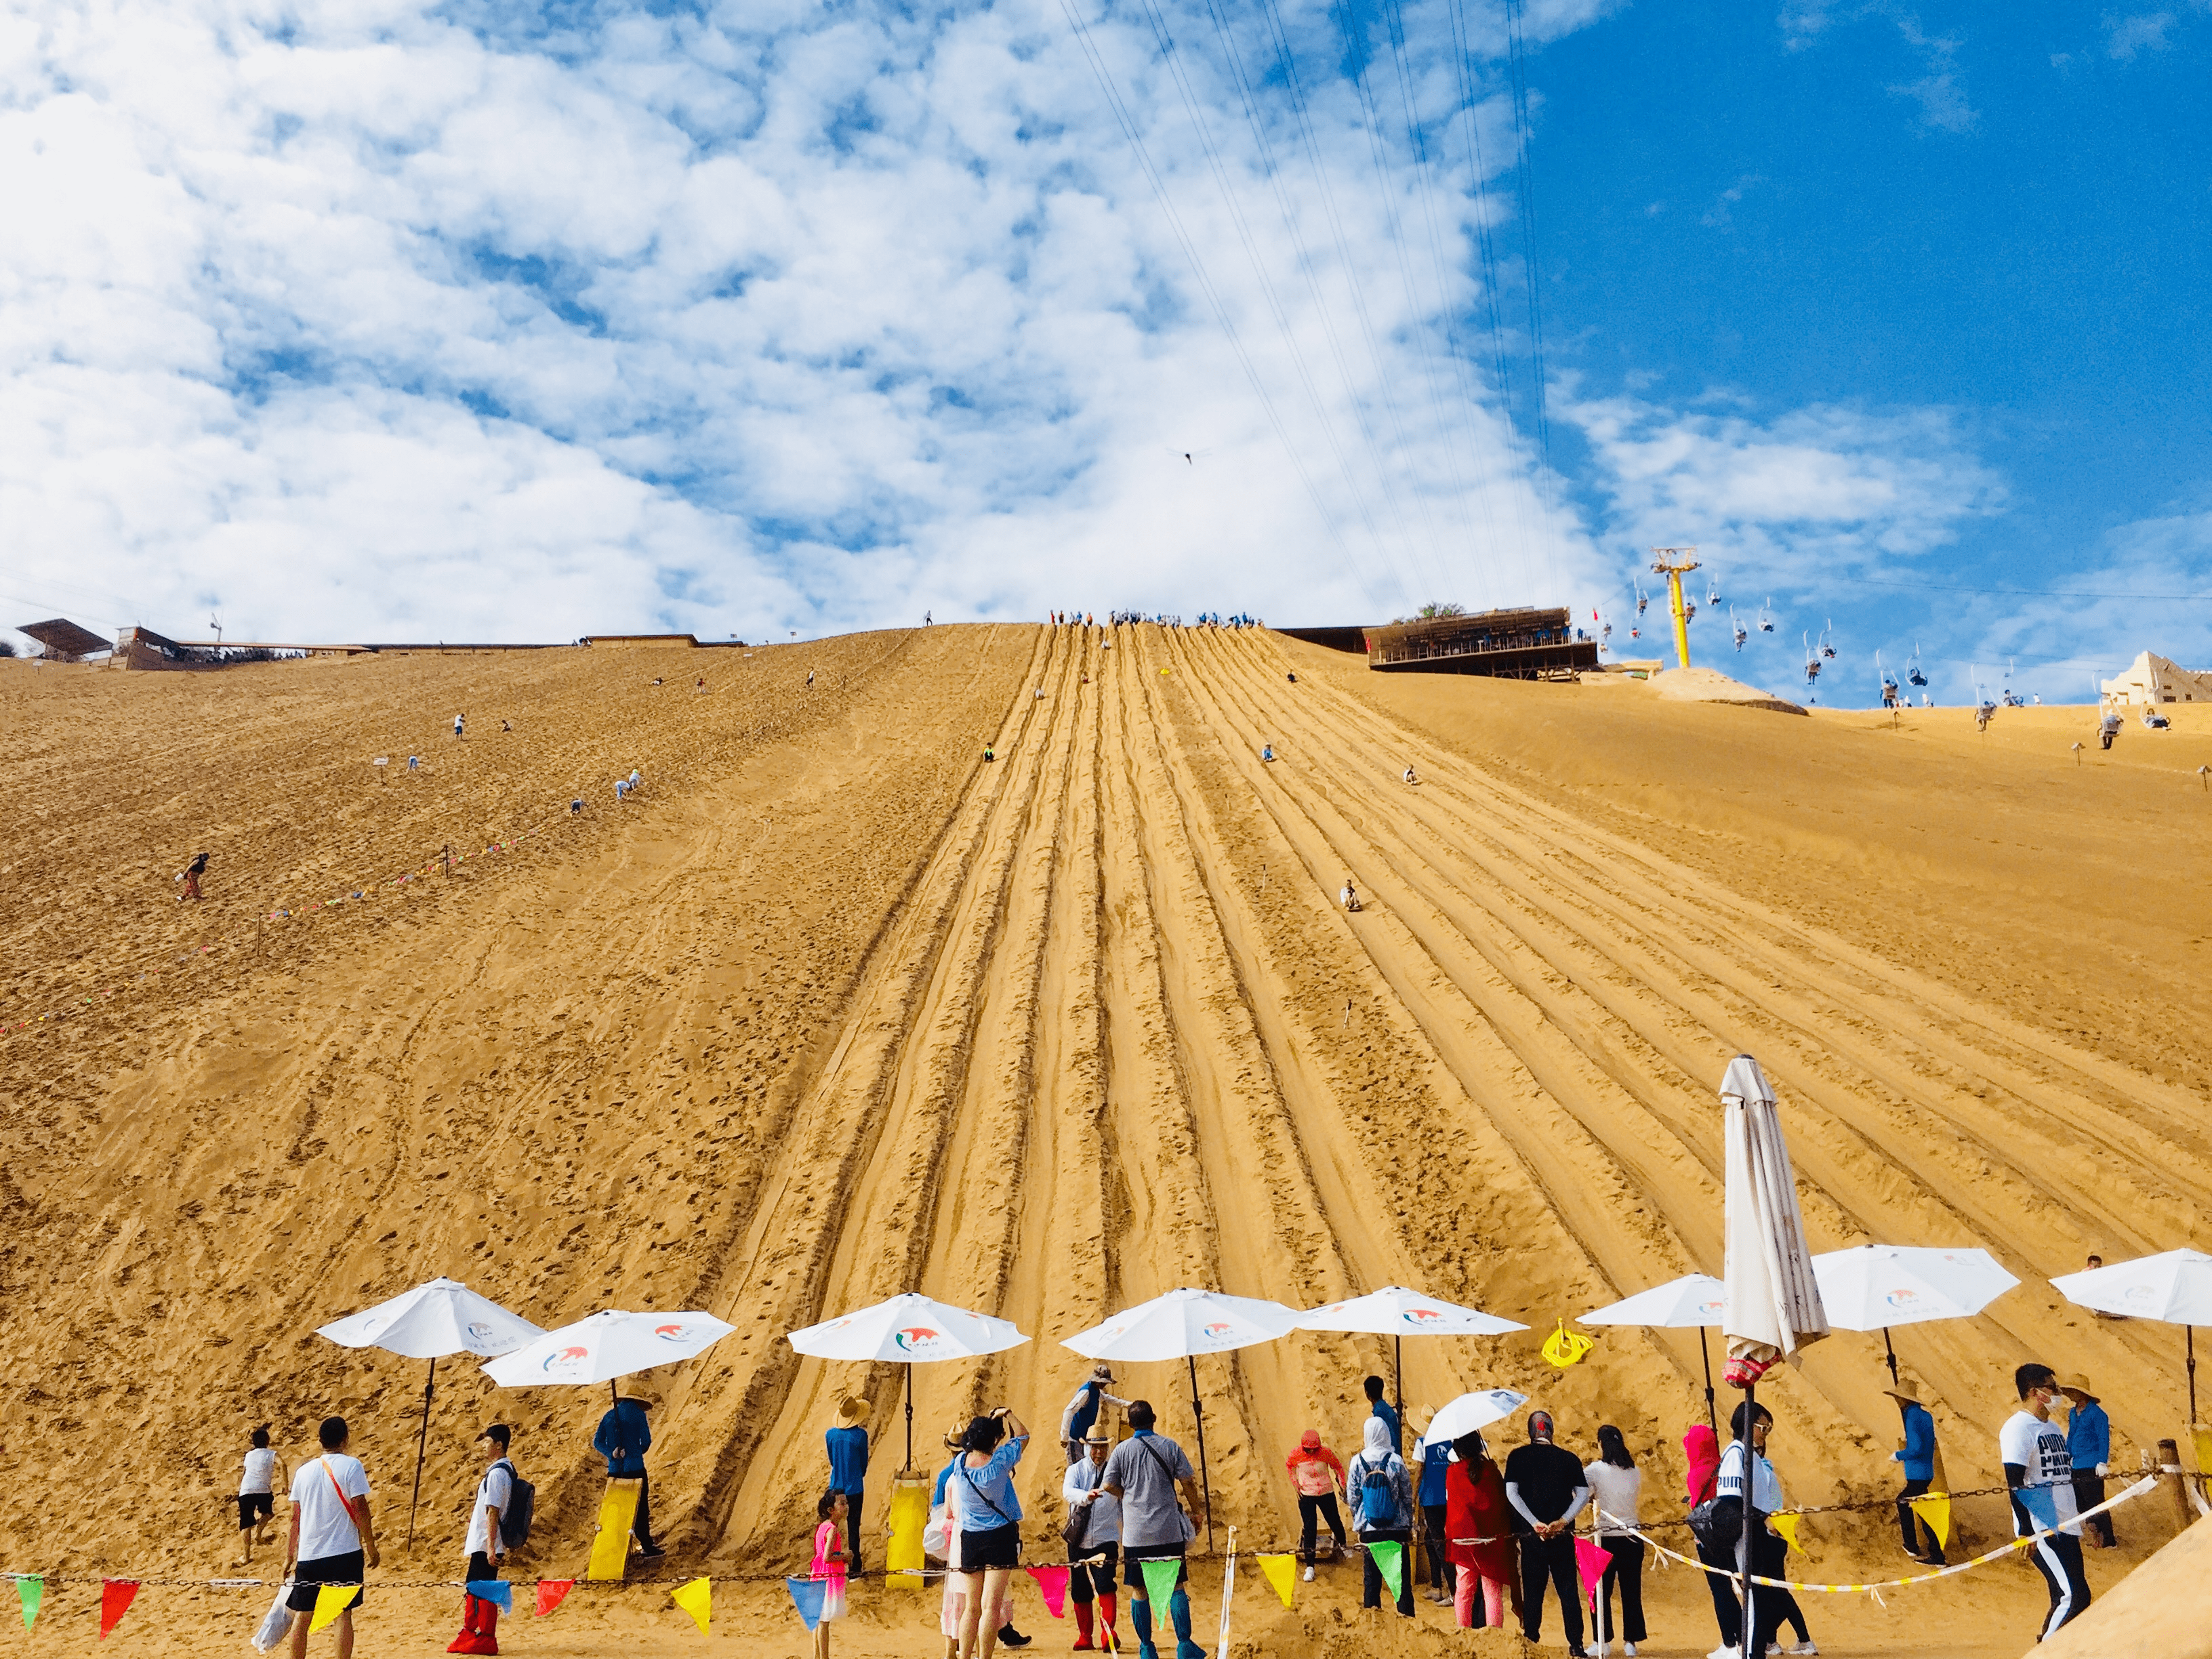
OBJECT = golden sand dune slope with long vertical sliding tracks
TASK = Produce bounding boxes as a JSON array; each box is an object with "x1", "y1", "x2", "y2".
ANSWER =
[{"x1": 0, "y1": 628, "x2": 2212, "y2": 1652}]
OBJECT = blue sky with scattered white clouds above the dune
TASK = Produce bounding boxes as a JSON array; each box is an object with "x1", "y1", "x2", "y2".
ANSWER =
[{"x1": 0, "y1": 0, "x2": 2212, "y2": 701}]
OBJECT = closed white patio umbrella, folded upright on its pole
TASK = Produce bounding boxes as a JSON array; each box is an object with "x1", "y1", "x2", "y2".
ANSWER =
[{"x1": 1721, "y1": 1055, "x2": 1827, "y2": 1631}]
